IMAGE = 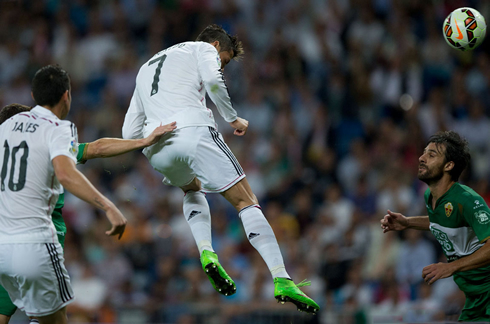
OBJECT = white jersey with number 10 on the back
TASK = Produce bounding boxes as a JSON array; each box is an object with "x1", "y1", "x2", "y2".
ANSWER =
[{"x1": 0, "y1": 106, "x2": 78, "y2": 243}]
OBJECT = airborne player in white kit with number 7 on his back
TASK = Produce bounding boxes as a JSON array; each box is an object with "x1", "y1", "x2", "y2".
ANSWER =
[{"x1": 122, "y1": 25, "x2": 319, "y2": 313}]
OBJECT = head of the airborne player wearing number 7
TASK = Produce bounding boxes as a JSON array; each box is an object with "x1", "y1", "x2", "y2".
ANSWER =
[{"x1": 196, "y1": 24, "x2": 243, "y2": 68}]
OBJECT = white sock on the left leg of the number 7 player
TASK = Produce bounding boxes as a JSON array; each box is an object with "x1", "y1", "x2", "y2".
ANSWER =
[{"x1": 184, "y1": 191, "x2": 214, "y2": 255}]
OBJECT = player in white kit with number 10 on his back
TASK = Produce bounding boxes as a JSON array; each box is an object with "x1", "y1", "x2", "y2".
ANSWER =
[{"x1": 0, "y1": 66, "x2": 127, "y2": 324}]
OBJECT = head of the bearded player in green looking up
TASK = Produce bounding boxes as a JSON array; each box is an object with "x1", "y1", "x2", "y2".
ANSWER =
[{"x1": 418, "y1": 131, "x2": 471, "y2": 184}]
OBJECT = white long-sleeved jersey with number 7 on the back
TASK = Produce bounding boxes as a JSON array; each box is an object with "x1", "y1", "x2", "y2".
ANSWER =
[{"x1": 122, "y1": 42, "x2": 237, "y2": 139}]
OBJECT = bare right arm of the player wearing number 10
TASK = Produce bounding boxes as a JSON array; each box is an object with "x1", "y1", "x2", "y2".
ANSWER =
[{"x1": 53, "y1": 155, "x2": 127, "y2": 238}]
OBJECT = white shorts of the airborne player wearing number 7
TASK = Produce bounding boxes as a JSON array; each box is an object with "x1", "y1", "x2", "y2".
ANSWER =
[{"x1": 143, "y1": 126, "x2": 245, "y2": 192}]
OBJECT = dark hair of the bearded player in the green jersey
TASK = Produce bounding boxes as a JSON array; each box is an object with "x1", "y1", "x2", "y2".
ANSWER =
[{"x1": 427, "y1": 131, "x2": 471, "y2": 181}]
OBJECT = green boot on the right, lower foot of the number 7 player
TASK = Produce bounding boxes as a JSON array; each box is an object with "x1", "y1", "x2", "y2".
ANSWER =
[{"x1": 274, "y1": 278, "x2": 320, "y2": 314}]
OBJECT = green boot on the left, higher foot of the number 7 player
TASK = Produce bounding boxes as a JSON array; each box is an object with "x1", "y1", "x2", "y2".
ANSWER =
[{"x1": 201, "y1": 250, "x2": 236, "y2": 296}]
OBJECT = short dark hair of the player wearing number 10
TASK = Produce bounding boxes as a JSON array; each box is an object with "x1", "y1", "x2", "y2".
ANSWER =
[{"x1": 32, "y1": 65, "x2": 70, "y2": 107}]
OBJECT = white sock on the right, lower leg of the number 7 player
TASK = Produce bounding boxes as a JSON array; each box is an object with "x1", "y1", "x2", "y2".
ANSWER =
[{"x1": 238, "y1": 205, "x2": 290, "y2": 278}]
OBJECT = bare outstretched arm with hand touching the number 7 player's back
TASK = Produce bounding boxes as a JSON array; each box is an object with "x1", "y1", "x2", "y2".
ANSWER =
[{"x1": 83, "y1": 122, "x2": 177, "y2": 160}]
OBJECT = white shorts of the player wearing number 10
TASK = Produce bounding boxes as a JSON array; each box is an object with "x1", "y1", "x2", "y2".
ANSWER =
[{"x1": 0, "y1": 243, "x2": 73, "y2": 316}]
